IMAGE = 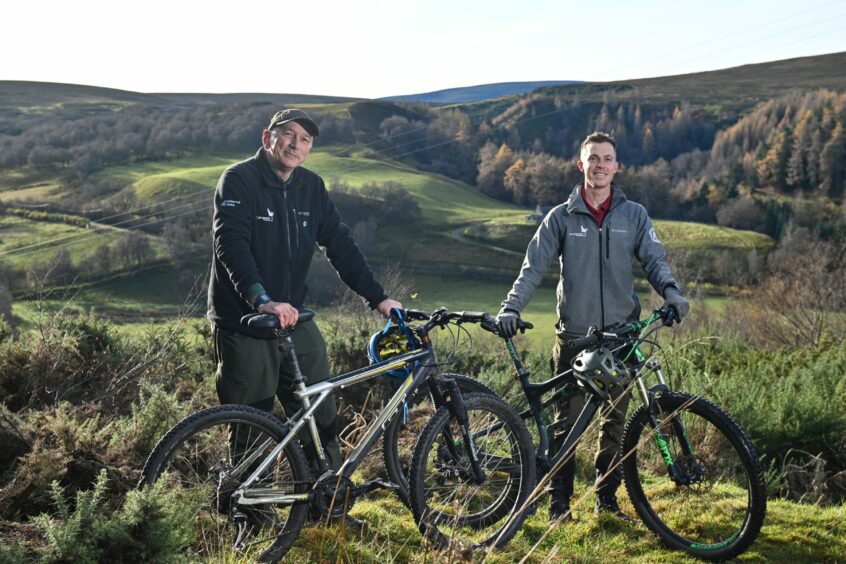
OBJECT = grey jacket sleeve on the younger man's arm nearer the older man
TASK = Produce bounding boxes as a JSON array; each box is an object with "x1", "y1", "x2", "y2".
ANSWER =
[{"x1": 501, "y1": 208, "x2": 565, "y2": 313}]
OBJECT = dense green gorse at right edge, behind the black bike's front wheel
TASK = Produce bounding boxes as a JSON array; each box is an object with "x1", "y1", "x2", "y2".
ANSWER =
[{"x1": 666, "y1": 336, "x2": 846, "y2": 500}]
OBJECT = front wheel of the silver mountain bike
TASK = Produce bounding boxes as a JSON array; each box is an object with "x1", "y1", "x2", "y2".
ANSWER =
[{"x1": 409, "y1": 394, "x2": 536, "y2": 548}]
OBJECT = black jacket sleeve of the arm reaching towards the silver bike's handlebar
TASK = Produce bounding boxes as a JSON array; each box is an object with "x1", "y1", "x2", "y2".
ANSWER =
[{"x1": 317, "y1": 179, "x2": 388, "y2": 308}]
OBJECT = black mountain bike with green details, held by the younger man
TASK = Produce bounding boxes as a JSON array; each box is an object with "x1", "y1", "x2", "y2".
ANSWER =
[{"x1": 384, "y1": 309, "x2": 766, "y2": 560}]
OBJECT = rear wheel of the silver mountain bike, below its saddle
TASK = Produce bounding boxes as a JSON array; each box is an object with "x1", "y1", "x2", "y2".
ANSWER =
[{"x1": 139, "y1": 405, "x2": 311, "y2": 562}]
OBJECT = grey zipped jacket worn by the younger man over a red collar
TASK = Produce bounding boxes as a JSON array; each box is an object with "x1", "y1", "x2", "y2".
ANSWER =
[{"x1": 502, "y1": 186, "x2": 680, "y2": 335}]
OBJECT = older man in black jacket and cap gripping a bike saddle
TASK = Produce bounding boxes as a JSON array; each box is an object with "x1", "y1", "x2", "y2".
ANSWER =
[{"x1": 208, "y1": 109, "x2": 402, "y2": 469}]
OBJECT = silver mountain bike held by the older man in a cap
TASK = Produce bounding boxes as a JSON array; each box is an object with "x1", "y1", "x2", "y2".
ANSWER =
[{"x1": 139, "y1": 308, "x2": 535, "y2": 562}]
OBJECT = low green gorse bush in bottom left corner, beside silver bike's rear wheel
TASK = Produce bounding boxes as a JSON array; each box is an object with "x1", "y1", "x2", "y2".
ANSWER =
[{"x1": 34, "y1": 472, "x2": 197, "y2": 563}]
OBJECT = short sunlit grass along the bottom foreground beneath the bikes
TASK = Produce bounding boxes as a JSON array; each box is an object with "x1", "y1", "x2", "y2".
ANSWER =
[{"x1": 286, "y1": 490, "x2": 846, "y2": 563}]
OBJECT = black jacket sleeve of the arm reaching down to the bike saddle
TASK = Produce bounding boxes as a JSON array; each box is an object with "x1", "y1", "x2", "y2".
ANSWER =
[{"x1": 213, "y1": 170, "x2": 263, "y2": 303}]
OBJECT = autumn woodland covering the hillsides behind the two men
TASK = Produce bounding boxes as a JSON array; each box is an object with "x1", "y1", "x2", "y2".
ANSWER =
[{"x1": 0, "y1": 84, "x2": 846, "y2": 245}]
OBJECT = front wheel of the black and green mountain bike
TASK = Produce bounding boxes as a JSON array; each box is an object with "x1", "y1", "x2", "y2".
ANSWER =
[{"x1": 621, "y1": 393, "x2": 767, "y2": 560}]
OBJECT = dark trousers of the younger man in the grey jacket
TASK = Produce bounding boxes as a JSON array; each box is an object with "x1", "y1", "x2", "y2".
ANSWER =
[{"x1": 549, "y1": 332, "x2": 630, "y2": 502}]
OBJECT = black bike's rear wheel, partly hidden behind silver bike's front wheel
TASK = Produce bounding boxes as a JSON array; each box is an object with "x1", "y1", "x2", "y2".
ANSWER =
[{"x1": 382, "y1": 374, "x2": 496, "y2": 507}]
